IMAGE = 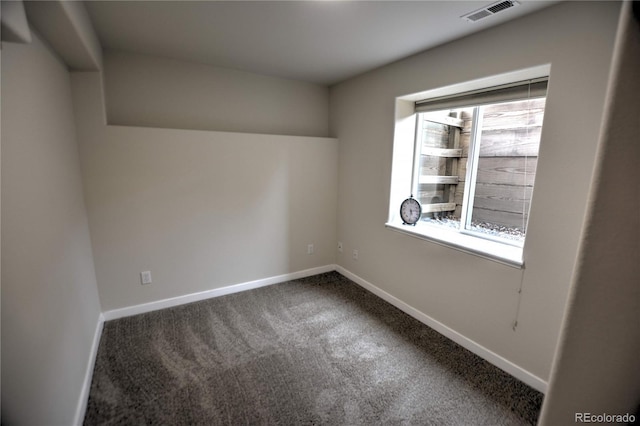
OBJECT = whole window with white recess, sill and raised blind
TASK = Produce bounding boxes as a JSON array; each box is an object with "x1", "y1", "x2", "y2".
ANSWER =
[{"x1": 387, "y1": 70, "x2": 548, "y2": 266}]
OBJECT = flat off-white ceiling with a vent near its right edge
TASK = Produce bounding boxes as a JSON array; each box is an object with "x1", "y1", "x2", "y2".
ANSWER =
[{"x1": 85, "y1": 0, "x2": 557, "y2": 85}]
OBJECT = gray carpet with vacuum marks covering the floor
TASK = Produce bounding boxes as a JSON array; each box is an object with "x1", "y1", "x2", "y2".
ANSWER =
[{"x1": 84, "y1": 272, "x2": 542, "y2": 425}]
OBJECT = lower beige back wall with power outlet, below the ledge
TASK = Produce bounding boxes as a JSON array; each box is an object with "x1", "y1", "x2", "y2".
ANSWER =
[{"x1": 72, "y1": 71, "x2": 338, "y2": 311}]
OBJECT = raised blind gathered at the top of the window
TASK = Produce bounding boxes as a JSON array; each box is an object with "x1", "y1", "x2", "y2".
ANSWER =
[{"x1": 416, "y1": 77, "x2": 549, "y2": 112}]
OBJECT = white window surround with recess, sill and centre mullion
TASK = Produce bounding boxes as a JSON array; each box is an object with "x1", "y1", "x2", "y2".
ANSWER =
[{"x1": 385, "y1": 65, "x2": 551, "y2": 268}]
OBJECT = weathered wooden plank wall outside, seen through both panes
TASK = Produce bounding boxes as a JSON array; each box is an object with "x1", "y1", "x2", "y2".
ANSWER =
[{"x1": 418, "y1": 99, "x2": 544, "y2": 231}]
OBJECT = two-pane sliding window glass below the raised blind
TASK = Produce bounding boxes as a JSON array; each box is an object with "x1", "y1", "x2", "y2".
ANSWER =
[{"x1": 413, "y1": 97, "x2": 545, "y2": 246}]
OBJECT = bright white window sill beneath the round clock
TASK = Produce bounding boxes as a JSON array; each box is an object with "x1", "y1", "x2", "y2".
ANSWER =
[{"x1": 385, "y1": 222, "x2": 524, "y2": 268}]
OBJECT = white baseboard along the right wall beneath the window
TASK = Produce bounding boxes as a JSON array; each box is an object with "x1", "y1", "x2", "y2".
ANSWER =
[{"x1": 336, "y1": 265, "x2": 548, "y2": 393}]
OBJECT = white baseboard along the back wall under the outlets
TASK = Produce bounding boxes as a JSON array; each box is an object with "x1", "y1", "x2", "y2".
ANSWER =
[{"x1": 102, "y1": 265, "x2": 336, "y2": 321}]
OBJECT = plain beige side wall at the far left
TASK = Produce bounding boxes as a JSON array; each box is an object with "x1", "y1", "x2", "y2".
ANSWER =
[{"x1": 2, "y1": 33, "x2": 100, "y2": 425}]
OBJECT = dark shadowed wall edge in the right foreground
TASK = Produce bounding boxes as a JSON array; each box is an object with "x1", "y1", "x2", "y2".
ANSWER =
[{"x1": 541, "y1": 3, "x2": 640, "y2": 425}]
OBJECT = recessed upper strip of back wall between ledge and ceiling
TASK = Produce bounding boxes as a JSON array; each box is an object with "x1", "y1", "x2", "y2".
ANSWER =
[{"x1": 104, "y1": 51, "x2": 329, "y2": 136}]
